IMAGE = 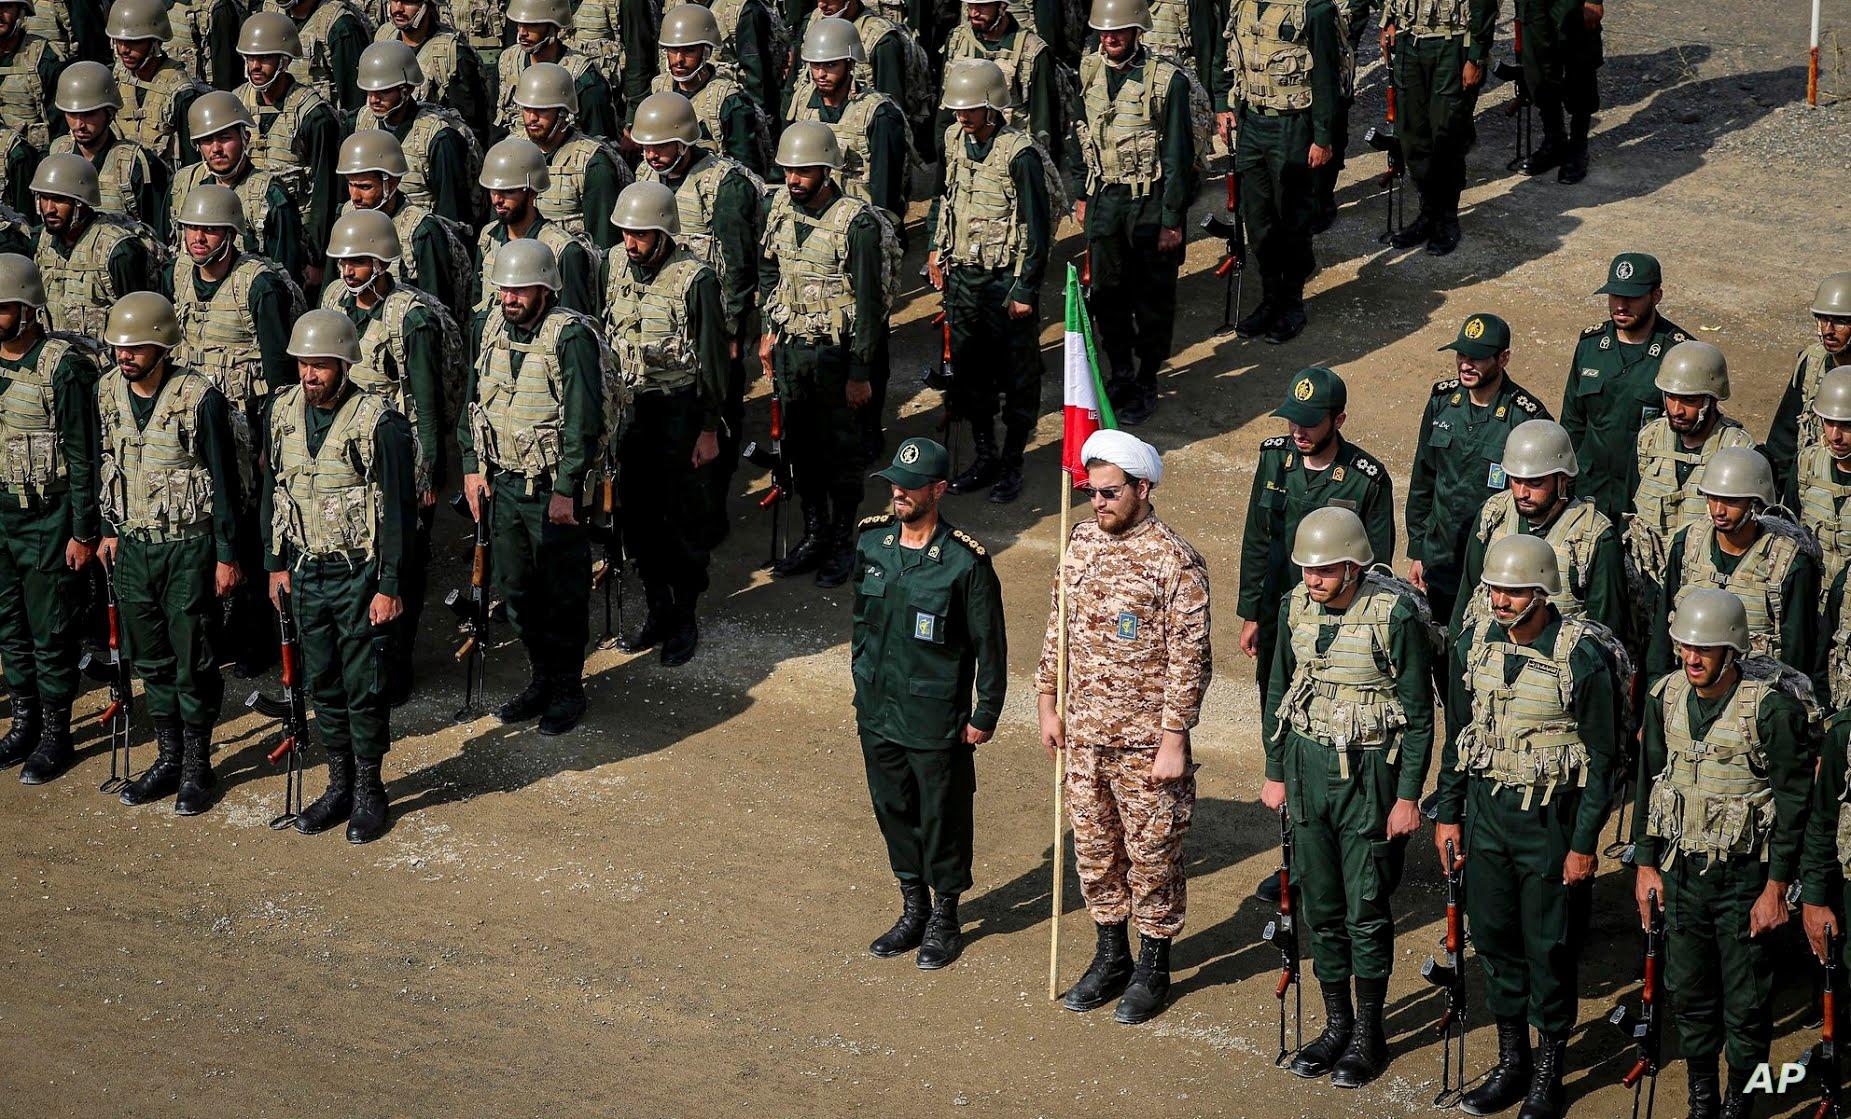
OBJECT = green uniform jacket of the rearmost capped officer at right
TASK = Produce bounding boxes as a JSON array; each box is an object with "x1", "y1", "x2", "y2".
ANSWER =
[{"x1": 1562, "y1": 314, "x2": 1690, "y2": 525}]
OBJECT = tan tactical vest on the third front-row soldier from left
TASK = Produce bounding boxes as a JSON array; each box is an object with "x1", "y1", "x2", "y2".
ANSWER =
[{"x1": 270, "y1": 385, "x2": 392, "y2": 566}]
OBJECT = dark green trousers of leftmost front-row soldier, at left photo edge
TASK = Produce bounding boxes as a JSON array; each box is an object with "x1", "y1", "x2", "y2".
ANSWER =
[{"x1": 0, "y1": 492, "x2": 85, "y2": 707}]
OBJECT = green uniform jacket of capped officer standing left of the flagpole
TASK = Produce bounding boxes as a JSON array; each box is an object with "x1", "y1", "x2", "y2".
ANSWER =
[{"x1": 851, "y1": 514, "x2": 1009, "y2": 749}]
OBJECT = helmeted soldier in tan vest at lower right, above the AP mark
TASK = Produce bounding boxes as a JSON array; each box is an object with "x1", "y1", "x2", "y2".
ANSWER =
[{"x1": 1628, "y1": 586, "x2": 1813, "y2": 1119}]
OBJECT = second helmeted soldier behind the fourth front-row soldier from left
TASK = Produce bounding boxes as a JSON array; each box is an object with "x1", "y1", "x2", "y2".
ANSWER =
[{"x1": 515, "y1": 63, "x2": 631, "y2": 252}]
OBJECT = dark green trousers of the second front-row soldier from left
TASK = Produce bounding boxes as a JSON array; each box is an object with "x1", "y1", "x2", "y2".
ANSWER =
[{"x1": 117, "y1": 533, "x2": 226, "y2": 727}]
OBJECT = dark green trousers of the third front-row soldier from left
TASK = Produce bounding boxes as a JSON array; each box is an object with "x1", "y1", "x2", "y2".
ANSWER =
[{"x1": 291, "y1": 559, "x2": 392, "y2": 758}]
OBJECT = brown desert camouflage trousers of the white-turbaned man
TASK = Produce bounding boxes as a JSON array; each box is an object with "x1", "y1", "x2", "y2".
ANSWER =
[{"x1": 1066, "y1": 744, "x2": 1196, "y2": 938}]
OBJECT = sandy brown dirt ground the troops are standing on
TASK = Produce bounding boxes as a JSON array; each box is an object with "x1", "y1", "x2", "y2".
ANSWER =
[{"x1": 0, "y1": 8, "x2": 1851, "y2": 1119}]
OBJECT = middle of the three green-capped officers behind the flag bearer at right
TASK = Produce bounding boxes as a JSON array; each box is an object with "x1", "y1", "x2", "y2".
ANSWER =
[{"x1": 1407, "y1": 314, "x2": 1549, "y2": 639}]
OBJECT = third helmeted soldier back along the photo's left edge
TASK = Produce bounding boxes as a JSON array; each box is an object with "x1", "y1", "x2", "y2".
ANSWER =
[{"x1": 52, "y1": 61, "x2": 172, "y2": 239}]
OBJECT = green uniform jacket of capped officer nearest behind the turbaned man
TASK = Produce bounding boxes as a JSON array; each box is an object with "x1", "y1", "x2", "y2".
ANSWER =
[{"x1": 1235, "y1": 435, "x2": 1394, "y2": 621}]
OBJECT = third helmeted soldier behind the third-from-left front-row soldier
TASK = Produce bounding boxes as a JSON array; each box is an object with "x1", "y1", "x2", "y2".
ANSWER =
[{"x1": 354, "y1": 43, "x2": 476, "y2": 229}]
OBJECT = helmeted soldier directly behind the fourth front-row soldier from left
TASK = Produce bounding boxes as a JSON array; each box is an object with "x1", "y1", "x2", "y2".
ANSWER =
[{"x1": 476, "y1": 137, "x2": 603, "y2": 314}]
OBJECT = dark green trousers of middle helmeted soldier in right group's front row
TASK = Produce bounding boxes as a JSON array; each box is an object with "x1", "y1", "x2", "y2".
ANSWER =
[{"x1": 1466, "y1": 777, "x2": 1590, "y2": 1038}]
